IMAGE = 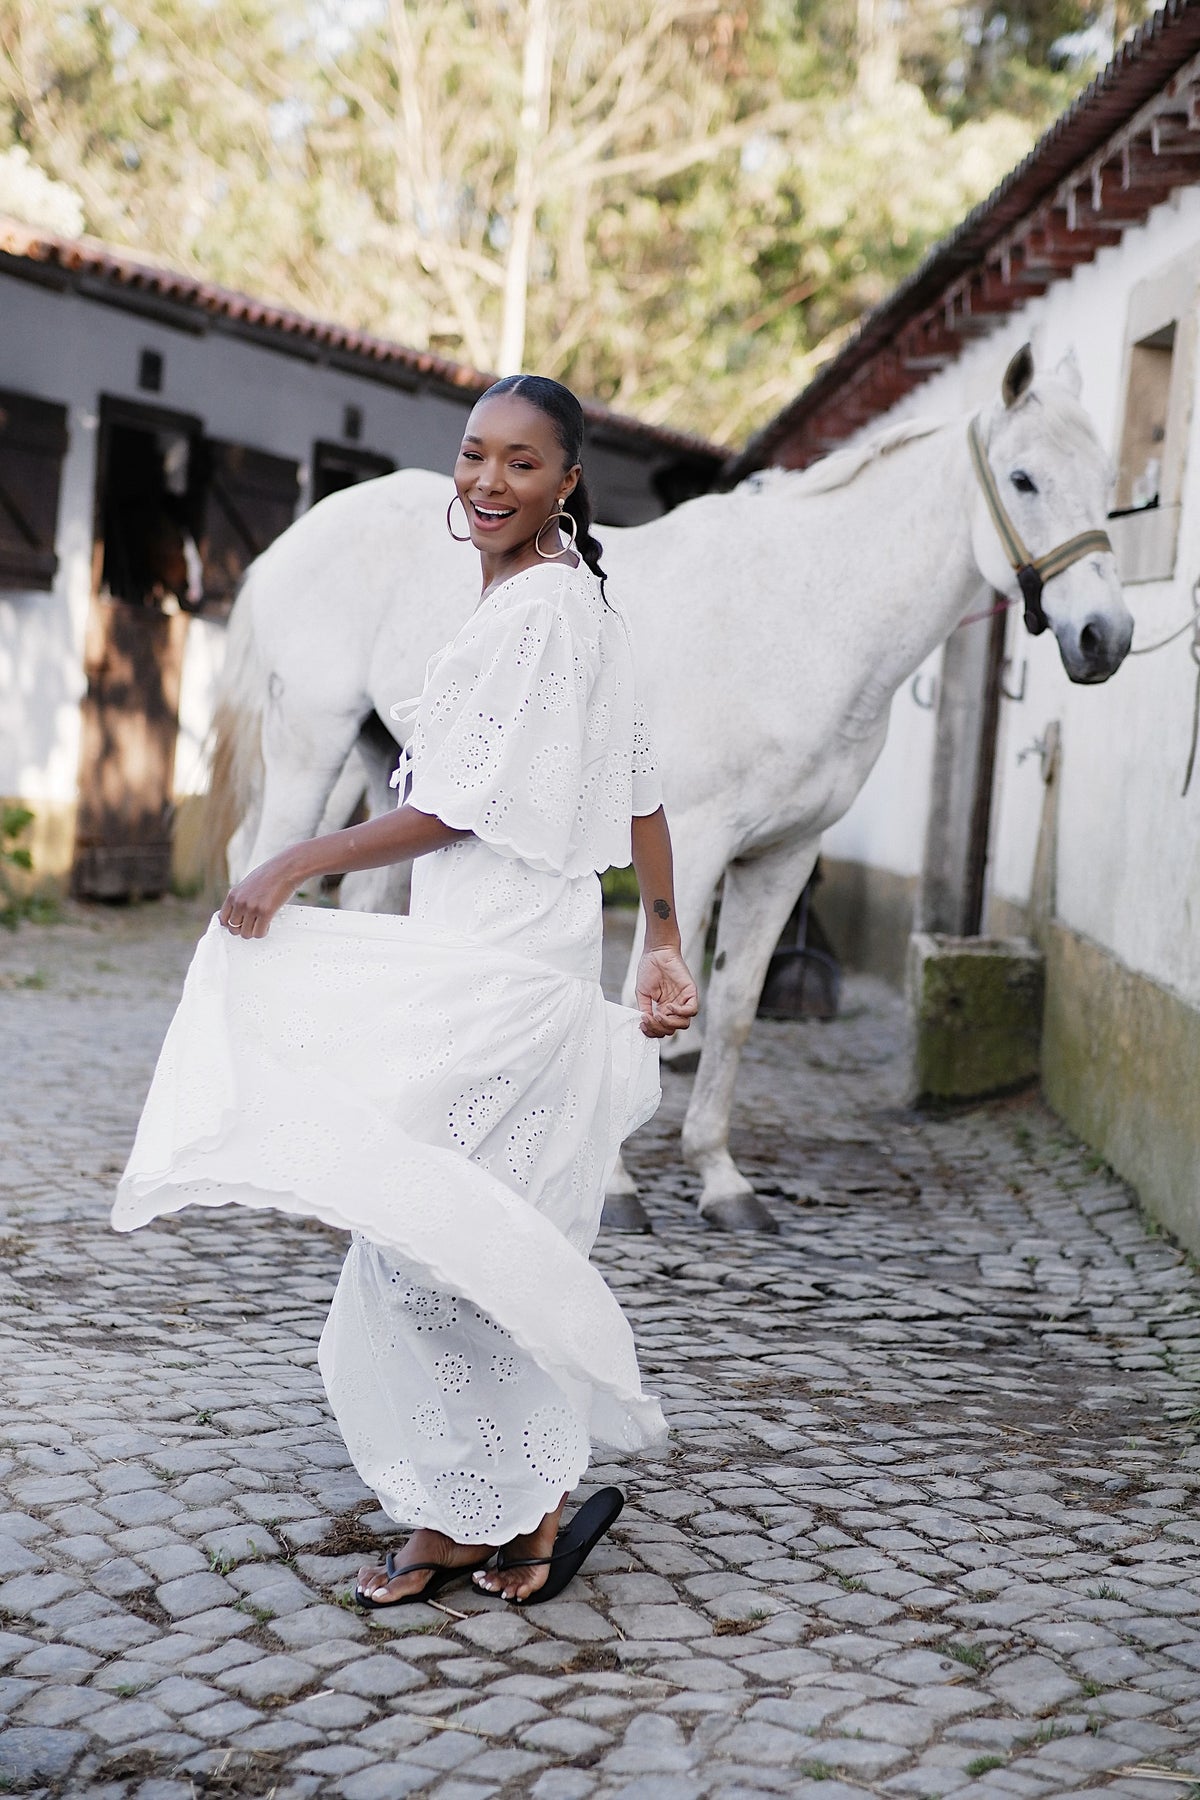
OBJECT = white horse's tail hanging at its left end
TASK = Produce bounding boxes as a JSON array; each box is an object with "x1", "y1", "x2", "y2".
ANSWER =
[{"x1": 203, "y1": 571, "x2": 266, "y2": 889}]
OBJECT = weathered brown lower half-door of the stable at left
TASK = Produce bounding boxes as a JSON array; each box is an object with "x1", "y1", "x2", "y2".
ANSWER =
[{"x1": 74, "y1": 594, "x2": 187, "y2": 900}]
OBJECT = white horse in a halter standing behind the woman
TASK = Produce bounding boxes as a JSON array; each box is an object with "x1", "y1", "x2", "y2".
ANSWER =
[{"x1": 214, "y1": 347, "x2": 1133, "y2": 1229}]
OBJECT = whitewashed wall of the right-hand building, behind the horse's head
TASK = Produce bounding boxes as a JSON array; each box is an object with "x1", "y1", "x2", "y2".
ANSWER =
[{"x1": 824, "y1": 189, "x2": 1200, "y2": 1004}]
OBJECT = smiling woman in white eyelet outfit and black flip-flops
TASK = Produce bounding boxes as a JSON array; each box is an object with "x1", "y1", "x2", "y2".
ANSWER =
[{"x1": 113, "y1": 376, "x2": 696, "y2": 1607}]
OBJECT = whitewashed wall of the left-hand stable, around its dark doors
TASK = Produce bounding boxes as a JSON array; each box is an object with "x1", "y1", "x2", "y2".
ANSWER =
[{"x1": 0, "y1": 277, "x2": 482, "y2": 808}]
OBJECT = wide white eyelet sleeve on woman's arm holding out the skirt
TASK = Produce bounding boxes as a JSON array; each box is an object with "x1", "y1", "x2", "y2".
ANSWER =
[{"x1": 408, "y1": 580, "x2": 597, "y2": 875}]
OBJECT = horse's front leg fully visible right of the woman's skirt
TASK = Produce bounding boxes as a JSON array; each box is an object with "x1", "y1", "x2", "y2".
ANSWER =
[{"x1": 684, "y1": 837, "x2": 820, "y2": 1231}]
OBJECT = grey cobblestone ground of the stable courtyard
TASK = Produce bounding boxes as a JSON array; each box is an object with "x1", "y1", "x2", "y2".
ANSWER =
[{"x1": 0, "y1": 904, "x2": 1200, "y2": 1800}]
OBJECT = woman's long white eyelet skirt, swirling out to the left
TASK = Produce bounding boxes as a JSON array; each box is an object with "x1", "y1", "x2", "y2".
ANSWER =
[{"x1": 113, "y1": 841, "x2": 666, "y2": 1543}]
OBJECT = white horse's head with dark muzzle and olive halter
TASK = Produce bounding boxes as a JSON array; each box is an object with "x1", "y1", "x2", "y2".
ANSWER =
[{"x1": 972, "y1": 344, "x2": 1133, "y2": 682}]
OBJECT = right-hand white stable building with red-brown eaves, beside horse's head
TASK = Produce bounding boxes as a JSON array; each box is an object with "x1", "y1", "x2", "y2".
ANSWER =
[{"x1": 727, "y1": 0, "x2": 1200, "y2": 1249}]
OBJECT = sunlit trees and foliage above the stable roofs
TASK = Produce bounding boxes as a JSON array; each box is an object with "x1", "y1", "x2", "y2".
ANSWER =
[{"x1": 0, "y1": 0, "x2": 1148, "y2": 441}]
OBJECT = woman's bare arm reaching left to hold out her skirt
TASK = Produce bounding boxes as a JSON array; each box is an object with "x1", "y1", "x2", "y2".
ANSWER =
[{"x1": 221, "y1": 806, "x2": 471, "y2": 938}]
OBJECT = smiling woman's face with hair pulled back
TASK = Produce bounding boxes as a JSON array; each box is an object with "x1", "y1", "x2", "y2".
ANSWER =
[{"x1": 453, "y1": 394, "x2": 579, "y2": 556}]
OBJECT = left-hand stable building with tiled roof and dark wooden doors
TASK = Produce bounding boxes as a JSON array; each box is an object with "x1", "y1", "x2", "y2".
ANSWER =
[{"x1": 0, "y1": 220, "x2": 721, "y2": 900}]
